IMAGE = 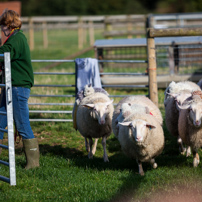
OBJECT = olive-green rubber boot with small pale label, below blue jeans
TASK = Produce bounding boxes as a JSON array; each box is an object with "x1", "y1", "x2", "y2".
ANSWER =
[{"x1": 22, "y1": 138, "x2": 39, "y2": 169}]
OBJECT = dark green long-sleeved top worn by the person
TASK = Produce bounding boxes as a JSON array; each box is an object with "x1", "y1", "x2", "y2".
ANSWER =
[{"x1": 0, "y1": 31, "x2": 34, "y2": 88}]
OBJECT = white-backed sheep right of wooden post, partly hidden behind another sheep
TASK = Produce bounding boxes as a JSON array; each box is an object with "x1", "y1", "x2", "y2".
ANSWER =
[{"x1": 164, "y1": 81, "x2": 200, "y2": 156}]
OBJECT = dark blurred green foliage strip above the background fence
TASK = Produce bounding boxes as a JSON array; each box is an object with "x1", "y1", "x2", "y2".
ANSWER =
[{"x1": 3, "y1": 0, "x2": 202, "y2": 16}]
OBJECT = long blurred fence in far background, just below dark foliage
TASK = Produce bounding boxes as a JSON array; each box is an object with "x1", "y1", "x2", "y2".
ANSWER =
[{"x1": 1, "y1": 13, "x2": 202, "y2": 50}]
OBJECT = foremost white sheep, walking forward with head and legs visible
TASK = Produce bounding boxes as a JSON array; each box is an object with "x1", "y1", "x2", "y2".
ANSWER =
[{"x1": 118, "y1": 113, "x2": 165, "y2": 175}]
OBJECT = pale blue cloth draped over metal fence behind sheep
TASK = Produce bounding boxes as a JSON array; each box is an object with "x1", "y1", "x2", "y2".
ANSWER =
[{"x1": 75, "y1": 58, "x2": 102, "y2": 92}]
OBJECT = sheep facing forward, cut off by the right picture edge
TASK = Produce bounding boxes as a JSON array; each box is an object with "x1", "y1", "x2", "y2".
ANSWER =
[{"x1": 178, "y1": 94, "x2": 202, "y2": 167}]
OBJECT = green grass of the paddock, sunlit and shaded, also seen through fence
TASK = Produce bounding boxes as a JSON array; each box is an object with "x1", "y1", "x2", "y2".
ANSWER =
[{"x1": 0, "y1": 29, "x2": 202, "y2": 202}]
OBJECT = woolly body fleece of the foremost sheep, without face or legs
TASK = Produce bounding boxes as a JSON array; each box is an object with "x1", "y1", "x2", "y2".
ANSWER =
[{"x1": 118, "y1": 114, "x2": 165, "y2": 162}]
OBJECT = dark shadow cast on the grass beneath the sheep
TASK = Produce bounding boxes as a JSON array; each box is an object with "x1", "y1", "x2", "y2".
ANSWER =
[{"x1": 13, "y1": 120, "x2": 191, "y2": 202}]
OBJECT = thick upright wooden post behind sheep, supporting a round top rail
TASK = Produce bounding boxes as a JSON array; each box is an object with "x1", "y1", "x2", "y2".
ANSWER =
[{"x1": 147, "y1": 31, "x2": 158, "y2": 106}]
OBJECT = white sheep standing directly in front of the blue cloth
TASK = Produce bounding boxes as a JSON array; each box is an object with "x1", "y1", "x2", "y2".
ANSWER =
[{"x1": 73, "y1": 86, "x2": 114, "y2": 162}]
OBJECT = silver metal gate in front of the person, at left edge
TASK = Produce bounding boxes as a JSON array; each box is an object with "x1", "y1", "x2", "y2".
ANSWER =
[{"x1": 0, "y1": 53, "x2": 16, "y2": 185}]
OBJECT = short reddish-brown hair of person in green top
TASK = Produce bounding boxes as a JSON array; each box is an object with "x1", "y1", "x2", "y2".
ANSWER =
[{"x1": 0, "y1": 9, "x2": 22, "y2": 29}]
